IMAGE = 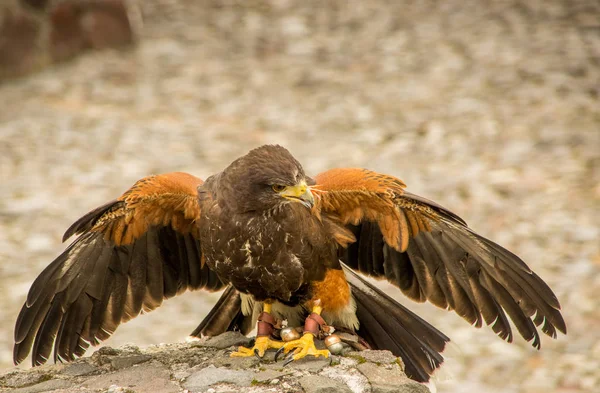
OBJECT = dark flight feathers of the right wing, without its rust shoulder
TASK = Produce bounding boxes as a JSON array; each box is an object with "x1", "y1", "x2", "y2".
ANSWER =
[{"x1": 341, "y1": 188, "x2": 566, "y2": 348}]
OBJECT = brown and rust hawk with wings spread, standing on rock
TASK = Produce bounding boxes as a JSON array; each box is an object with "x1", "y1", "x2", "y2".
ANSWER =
[{"x1": 14, "y1": 145, "x2": 566, "y2": 381}]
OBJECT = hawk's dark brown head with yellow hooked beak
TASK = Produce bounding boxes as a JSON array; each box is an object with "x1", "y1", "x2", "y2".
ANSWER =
[{"x1": 219, "y1": 145, "x2": 314, "y2": 213}]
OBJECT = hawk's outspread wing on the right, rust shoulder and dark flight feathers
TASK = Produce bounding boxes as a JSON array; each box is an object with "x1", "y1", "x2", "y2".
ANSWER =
[{"x1": 313, "y1": 169, "x2": 566, "y2": 348}]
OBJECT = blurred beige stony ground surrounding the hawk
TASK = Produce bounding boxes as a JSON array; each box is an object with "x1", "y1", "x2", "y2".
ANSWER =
[{"x1": 0, "y1": 0, "x2": 600, "y2": 393}]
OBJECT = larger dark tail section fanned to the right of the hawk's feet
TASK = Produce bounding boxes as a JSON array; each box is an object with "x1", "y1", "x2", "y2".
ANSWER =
[{"x1": 344, "y1": 267, "x2": 450, "y2": 382}]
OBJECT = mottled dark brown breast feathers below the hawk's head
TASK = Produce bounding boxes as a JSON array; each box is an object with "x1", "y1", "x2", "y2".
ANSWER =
[{"x1": 200, "y1": 205, "x2": 336, "y2": 301}]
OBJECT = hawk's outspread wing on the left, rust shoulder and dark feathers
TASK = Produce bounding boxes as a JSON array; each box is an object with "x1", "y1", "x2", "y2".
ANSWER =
[{"x1": 13, "y1": 173, "x2": 223, "y2": 365}]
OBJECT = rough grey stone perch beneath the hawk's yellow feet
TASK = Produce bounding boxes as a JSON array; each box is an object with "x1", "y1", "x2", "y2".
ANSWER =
[{"x1": 0, "y1": 332, "x2": 429, "y2": 393}]
